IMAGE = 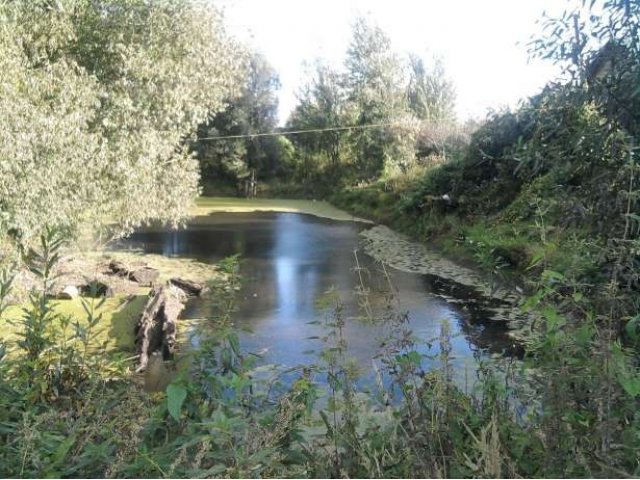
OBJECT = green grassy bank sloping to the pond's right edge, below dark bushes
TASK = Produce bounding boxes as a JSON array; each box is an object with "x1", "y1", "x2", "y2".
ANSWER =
[{"x1": 329, "y1": 160, "x2": 613, "y2": 300}]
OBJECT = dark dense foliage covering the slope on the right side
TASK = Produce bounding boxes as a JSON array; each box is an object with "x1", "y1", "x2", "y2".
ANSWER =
[{"x1": 384, "y1": 2, "x2": 640, "y2": 292}]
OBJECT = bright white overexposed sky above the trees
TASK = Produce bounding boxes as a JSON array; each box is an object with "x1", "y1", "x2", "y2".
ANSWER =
[{"x1": 212, "y1": 0, "x2": 567, "y2": 124}]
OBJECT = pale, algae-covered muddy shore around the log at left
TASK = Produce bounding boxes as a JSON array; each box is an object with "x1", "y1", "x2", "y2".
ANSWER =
[{"x1": 0, "y1": 248, "x2": 226, "y2": 354}]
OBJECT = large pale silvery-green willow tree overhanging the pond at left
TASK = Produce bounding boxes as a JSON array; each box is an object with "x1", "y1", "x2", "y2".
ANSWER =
[{"x1": 0, "y1": 0, "x2": 245, "y2": 248}]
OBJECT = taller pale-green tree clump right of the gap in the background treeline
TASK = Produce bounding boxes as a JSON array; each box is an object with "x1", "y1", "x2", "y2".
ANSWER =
[{"x1": 287, "y1": 18, "x2": 455, "y2": 193}]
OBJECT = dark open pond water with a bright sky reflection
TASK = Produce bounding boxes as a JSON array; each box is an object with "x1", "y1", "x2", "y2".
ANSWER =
[{"x1": 123, "y1": 212, "x2": 518, "y2": 390}]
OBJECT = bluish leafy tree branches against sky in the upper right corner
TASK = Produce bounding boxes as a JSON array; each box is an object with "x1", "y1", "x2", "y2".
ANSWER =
[{"x1": 530, "y1": 0, "x2": 640, "y2": 135}]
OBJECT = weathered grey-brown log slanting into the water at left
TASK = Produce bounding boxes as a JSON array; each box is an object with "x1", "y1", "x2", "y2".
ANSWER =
[{"x1": 136, "y1": 286, "x2": 186, "y2": 372}]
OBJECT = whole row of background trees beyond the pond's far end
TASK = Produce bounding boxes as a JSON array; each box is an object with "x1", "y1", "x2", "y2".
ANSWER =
[{"x1": 194, "y1": 18, "x2": 466, "y2": 196}]
